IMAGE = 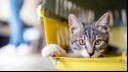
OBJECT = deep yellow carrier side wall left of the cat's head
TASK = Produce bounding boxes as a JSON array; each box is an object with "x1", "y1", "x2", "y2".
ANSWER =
[{"x1": 39, "y1": 10, "x2": 69, "y2": 48}]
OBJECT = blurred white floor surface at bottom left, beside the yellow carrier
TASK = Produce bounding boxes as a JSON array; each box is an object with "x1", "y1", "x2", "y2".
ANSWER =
[{"x1": 0, "y1": 55, "x2": 55, "y2": 71}]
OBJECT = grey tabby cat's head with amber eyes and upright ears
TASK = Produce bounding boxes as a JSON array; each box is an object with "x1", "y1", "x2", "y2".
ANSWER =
[{"x1": 68, "y1": 13, "x2": 110, "y2": 57}]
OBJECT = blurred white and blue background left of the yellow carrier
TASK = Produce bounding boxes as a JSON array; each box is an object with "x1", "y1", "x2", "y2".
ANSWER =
[{"x1": 0, "y1": 0, "x2": 54, "y2": 71}]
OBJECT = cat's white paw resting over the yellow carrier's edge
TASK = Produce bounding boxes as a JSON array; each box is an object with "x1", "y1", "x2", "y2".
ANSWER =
[{"x1": 42, "y1": 44, "x2": 66, "y2": 57}]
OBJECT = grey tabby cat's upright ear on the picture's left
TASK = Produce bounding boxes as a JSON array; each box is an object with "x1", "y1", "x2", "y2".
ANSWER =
[{"x1": 68, "y1": 14, "x2": 83, "y2": 34}]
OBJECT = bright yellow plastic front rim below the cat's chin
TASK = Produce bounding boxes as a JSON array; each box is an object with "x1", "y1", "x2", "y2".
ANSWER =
[{"x1": 51, "y1": 56, "x2": 126, "y2": 71}]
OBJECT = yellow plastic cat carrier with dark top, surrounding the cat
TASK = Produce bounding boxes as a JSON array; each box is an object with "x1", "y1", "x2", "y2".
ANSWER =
[{"x1": 38, "y1": 0, "x2": 127, "y2": 71}]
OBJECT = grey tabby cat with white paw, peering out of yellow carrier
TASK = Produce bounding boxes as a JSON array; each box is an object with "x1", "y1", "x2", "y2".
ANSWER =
[{"x1": 42, "y1": 13, "x2": 123, "y2": 58}]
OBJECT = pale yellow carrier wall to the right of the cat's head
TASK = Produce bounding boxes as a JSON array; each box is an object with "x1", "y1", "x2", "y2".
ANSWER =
[{"x1": 109, "y1": 26, "x2": 127, "y2": 49}]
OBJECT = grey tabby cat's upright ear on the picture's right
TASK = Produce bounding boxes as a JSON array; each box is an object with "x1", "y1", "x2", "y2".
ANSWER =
[{"x1": 95, "y1": 12, "x2": 110, "y2": 33}]
